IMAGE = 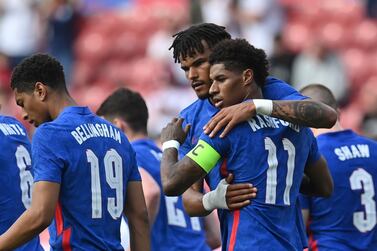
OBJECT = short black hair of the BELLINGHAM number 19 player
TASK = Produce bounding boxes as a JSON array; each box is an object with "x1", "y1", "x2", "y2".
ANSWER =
[{"x1": 10, "y1": 54, "x2": 67, "y2": 92}]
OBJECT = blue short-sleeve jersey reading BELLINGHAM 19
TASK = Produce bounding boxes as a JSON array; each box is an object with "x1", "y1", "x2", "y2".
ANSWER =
[{"x1": 32, "y1": 107, "x2": 141, "y2": 250}]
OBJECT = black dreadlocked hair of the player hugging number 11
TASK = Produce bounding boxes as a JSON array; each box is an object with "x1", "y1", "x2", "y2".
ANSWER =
[{"x1": 169, "y1": 23, "x2": 231, "y2": 63}]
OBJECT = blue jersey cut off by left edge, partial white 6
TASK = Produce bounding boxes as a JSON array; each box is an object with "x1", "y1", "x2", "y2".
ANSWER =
[{"x1": 0, "y1": 116, "x2": 43, "y2": 251}]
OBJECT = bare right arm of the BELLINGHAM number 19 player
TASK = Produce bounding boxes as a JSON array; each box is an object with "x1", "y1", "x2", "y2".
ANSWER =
[{"x1": 124, "y1": 181, "x2": 150, "y2": 251}]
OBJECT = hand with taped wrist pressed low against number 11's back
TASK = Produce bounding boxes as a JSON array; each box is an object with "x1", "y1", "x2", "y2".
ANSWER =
[{"x1": 225, "y1": 174, "x2": 258, "y2": 210}]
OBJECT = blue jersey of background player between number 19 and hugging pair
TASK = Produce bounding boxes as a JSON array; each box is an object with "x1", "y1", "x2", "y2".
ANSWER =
[{"x1": 131, "y1": 139, "x2": 210, "y2": 251}]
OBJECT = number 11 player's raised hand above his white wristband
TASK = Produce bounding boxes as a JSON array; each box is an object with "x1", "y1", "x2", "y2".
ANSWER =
[{"x1": 161, "y1": 118, "x2": 190, "y2": 144}]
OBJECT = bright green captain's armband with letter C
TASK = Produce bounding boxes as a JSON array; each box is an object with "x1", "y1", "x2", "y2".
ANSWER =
[{"x1": 186, "y1": 140, "x2": 221, "y2": 173}]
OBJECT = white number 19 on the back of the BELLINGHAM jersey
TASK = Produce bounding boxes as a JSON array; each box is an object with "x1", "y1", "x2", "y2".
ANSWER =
[{"x1": 86, "y1": 149, "x2": 123, "y2": 219}]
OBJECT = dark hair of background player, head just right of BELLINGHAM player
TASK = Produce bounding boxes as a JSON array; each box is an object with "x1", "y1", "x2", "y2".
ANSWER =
[{"x1": 97, "y1": 88, "x2": 148, "y2": 133}]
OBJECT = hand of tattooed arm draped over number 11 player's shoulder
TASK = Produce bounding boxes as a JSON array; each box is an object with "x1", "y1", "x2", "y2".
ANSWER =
[{"x1": 203, "y1": 102, "x2": 256, "y2": 138}]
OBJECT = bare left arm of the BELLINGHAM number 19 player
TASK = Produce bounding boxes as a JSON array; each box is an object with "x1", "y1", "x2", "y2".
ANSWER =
[{"x1": 0, "y1": 181, "x2": 60, "y2": 250}]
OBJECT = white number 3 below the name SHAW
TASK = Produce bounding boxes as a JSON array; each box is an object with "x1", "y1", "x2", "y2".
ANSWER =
[{"x1": 350, "y1": 168, "x2": 377, "y2": 233}]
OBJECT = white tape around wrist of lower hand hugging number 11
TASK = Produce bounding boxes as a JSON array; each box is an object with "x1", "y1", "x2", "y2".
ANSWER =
[{"x1": 202, "y1": 179, "x2": 229, "y2": 211}]
